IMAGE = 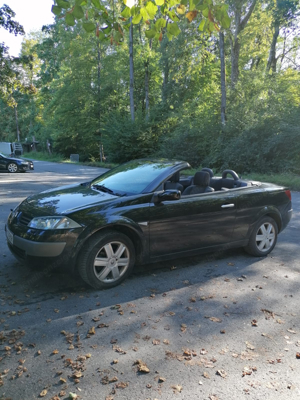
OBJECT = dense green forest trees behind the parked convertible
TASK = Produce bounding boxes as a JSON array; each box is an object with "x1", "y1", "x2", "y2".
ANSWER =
[{"x1": 0, "y1": 0, "x2": 300, "y2": 173}]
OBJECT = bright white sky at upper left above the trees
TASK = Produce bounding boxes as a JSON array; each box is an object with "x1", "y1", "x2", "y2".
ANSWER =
[{"x1": 0, "y1": 0, "x2": 54, "y2": 57}]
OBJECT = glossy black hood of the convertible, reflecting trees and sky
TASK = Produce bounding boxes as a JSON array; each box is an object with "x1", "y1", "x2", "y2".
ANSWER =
[{"x1": 22, "y1": 185, "x2": 118, "y2": 216}]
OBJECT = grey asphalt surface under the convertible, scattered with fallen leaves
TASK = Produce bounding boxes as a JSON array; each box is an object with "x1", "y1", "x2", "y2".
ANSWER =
[{"x1": 0, "y1": 161, "x2": 300, "y2": 400}]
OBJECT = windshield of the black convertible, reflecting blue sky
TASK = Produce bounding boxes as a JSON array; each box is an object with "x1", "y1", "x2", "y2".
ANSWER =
[{"x1": 91, "y1": 160, "x2": 174, "y2": 194}]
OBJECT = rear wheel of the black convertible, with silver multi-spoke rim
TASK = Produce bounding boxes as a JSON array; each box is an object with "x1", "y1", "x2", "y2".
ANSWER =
[{"x1": 245, "y1": 217, "x2": 278, "y2": 257}]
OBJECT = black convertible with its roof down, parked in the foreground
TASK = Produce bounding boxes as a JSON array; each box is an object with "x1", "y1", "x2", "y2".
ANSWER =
[{"x1": 5, "y1": 159, "x2": 292, "y2": 288}]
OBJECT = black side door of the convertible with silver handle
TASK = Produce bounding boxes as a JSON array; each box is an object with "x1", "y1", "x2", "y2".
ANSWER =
[{"x1": 150, "y1": 191, "x2": 236, "y2": 258}]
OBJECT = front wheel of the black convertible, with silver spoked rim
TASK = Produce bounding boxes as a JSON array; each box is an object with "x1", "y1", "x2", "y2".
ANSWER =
[{"x1": 77, "y1": 231, "x2": 135, "y2": 289}]
